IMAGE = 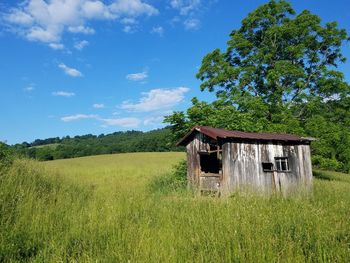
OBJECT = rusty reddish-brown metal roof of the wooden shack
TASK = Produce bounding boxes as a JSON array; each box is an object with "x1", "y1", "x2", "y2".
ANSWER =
[{"x1": 177, "y1": 126, "x2": 312, "y2": 145}]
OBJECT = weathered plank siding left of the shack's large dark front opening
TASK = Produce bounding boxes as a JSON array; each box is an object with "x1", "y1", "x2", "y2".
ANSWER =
[{"x1": 186, "y1": 133, "x2": 210, "y2": 186}]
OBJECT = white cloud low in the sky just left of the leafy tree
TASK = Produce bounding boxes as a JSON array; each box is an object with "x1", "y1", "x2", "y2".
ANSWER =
[{"x1": 121, "y1": 87, "x2": 189, "y2": 112}]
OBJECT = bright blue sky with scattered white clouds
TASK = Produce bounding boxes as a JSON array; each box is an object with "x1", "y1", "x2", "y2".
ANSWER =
[{"x1": 0, "y1": 0, "x2": 350, "y2": 144}]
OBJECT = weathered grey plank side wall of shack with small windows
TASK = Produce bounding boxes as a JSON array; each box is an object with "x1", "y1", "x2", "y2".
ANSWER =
[{"x1": 221, "y1": 142, "x2": 312, "y2": 194}]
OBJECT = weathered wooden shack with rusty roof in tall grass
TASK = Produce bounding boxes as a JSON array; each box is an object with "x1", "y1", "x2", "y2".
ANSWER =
[{"x1": 178, "y1": 126, "x2": 312, "y2": 194}]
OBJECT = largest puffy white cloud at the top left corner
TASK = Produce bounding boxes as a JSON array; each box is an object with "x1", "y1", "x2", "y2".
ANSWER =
[{"x1": 3, "y1": 0, "x2": 159, "y2": 43}]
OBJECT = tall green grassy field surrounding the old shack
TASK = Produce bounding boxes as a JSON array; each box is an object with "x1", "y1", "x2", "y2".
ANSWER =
[{"x1": 0, "y1": 153, "x2": 350, "y2": 262}]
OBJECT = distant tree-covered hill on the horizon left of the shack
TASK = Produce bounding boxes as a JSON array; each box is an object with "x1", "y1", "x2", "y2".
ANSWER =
[{"x1": 12, "y1": 128, "x2": 183, "y2": 161}]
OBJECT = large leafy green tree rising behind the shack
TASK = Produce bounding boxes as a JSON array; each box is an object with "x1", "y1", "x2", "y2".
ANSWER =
[{"x1": 166, "y1": 1, "x2": 350, "y2": 172}]
